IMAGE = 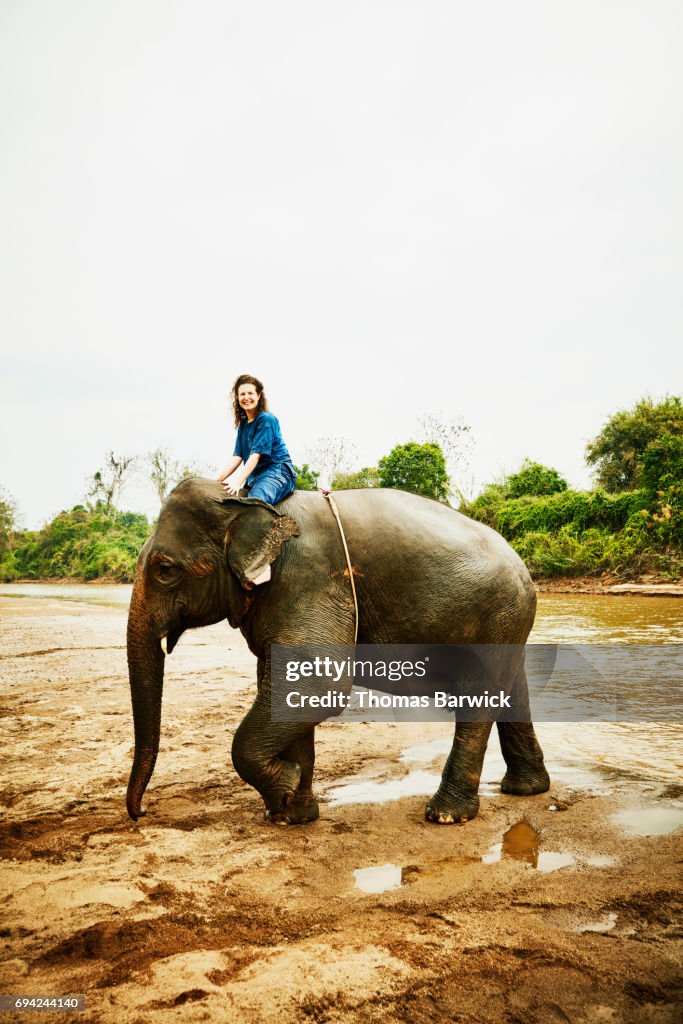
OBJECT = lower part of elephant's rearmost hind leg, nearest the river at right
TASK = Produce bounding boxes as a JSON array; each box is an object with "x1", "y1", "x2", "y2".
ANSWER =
[{"x1": 498, "y1": 666, "x2": 550, "y2": 797}]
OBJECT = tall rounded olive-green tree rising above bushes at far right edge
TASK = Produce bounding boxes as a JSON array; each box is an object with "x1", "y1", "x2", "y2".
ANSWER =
[{"x1": 586, "y1": 395, "x2": 683, "y2": 493}]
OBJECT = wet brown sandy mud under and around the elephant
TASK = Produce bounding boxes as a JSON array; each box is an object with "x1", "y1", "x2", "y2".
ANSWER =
[{"x1": 0, "y1": 598, "x2": 682, "y2": 1024}]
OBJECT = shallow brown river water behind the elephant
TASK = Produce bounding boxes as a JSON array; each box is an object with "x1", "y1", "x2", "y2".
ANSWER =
[{"x1": 0, "y1": 584, "x2": 683, "y2": 792}]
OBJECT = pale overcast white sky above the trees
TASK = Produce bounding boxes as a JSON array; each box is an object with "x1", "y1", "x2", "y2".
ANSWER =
[{"x1": 0, "y1": 0, "x2": 683, "y2": 527}]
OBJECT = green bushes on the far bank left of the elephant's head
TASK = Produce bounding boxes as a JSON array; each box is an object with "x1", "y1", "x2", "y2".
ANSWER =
[{"x1": 0, "y1": 502, "x2": 152, "y2": 583}]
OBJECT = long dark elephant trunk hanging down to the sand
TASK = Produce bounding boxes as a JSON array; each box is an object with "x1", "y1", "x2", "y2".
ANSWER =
[{"x1": 126, "y1": 583, "x2": 164, "y2": 821}]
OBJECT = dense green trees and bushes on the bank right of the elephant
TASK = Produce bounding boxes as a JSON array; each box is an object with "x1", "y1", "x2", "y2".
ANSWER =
[{"x1": 461, "y1": 397, "x2": 683, "y2": 580}]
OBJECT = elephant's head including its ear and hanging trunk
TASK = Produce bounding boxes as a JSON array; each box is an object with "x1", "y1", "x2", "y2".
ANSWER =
[{"x1": 126, "y1": 479, "x2": 299, "y2": 821}]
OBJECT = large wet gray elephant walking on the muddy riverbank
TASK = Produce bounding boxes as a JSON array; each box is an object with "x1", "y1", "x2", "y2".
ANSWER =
[{"x1": 127, "y1": 479, "x2": 550, "y2": 824}]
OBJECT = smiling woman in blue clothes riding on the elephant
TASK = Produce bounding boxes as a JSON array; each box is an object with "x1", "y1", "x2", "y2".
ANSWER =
[{"x1": 218, "y1": 374, "x2": 296, "y2": 505}]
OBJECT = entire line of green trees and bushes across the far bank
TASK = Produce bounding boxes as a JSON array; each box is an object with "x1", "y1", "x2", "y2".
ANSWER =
[{"x1": 0, "y1": 397, "x2": 683, "y2": 582}]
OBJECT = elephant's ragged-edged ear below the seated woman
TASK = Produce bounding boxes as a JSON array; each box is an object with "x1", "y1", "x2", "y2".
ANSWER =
[{"x1": 223, "y1": 498, "x2": 299, "y2": 590}]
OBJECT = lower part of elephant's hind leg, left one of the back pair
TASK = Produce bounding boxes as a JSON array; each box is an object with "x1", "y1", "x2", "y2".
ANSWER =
[{"x1": 425, "y1": 722, "x2": 493, "y2": 825}]
